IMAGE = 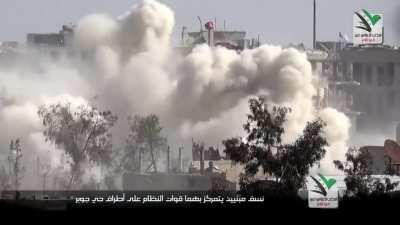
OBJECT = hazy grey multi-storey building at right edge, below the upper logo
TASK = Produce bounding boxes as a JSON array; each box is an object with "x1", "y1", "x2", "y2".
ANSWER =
[{"x1": 340, "y1": 46, "x2": 400, "y2": 129}]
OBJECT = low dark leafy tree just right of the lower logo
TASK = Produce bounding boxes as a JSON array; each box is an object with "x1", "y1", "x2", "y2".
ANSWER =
[{"x1": 334, "y1": 148, "x2": 398, "y2": 197}]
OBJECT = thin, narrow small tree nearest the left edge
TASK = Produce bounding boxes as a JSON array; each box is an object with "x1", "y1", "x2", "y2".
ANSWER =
[{"x1": 7, "y1": 139, "x2": 25, "y2": 191}]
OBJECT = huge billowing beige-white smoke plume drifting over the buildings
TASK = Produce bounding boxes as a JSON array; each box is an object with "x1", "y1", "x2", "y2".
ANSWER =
[{"x1": 0, "y1": 0, "x2": 350, "y2": 188}]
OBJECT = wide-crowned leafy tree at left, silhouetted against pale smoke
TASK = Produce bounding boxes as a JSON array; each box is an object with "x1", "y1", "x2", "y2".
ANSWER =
[{"x1": 38, "y1": 103, "x2": 117, "y2": 189}]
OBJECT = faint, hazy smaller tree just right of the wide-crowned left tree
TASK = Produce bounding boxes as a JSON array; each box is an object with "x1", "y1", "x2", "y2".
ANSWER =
[{"x1": 124, "y1": 114, "x2": 167, "y2": 172}]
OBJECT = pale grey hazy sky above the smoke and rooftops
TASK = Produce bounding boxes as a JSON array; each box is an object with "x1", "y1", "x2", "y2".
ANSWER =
[{"x1": 0, "y1": 0, "x2": 400, "y2": 46}]
